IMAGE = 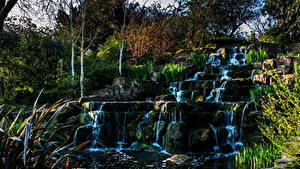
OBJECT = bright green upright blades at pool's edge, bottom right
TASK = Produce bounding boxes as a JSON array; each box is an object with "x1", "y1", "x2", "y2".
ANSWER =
[{"x1": 235, "y1": 144, "x2": 282, "y2": 169}]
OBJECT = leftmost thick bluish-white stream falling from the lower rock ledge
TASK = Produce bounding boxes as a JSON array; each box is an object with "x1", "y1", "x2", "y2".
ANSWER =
[{"x1": 92, "y1": 104, "x2": 104, "y2": 148}]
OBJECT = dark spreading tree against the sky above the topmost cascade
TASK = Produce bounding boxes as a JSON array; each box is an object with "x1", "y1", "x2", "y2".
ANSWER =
[{"x1": 188, "y1": 0, "x2": 260, "y2": 37}]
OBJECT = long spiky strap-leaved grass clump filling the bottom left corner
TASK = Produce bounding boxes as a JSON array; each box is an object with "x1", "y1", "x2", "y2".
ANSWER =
[{"x1": 0, "y1": 90, "x2": 88, "y2": 169}]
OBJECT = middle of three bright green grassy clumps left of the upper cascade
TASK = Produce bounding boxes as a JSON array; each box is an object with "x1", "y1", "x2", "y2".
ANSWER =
[{"x1": 160, "y1": 63, "x2": 185, "y2": 82}]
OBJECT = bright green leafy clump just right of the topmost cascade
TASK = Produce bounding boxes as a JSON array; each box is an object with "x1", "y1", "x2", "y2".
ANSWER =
[{"x1": 246, "y1": 49, "x2": 269, "y2": 64}]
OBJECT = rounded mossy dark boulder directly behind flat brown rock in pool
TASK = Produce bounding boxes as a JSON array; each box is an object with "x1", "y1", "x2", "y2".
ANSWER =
[{"x1": 164, "y1": 122, "x2": 188, "y2": 153}]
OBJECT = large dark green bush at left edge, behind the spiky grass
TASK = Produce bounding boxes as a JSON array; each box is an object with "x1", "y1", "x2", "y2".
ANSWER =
[{"x1": 0, "y1": 31, "x2": 70, "y2": 104}]
